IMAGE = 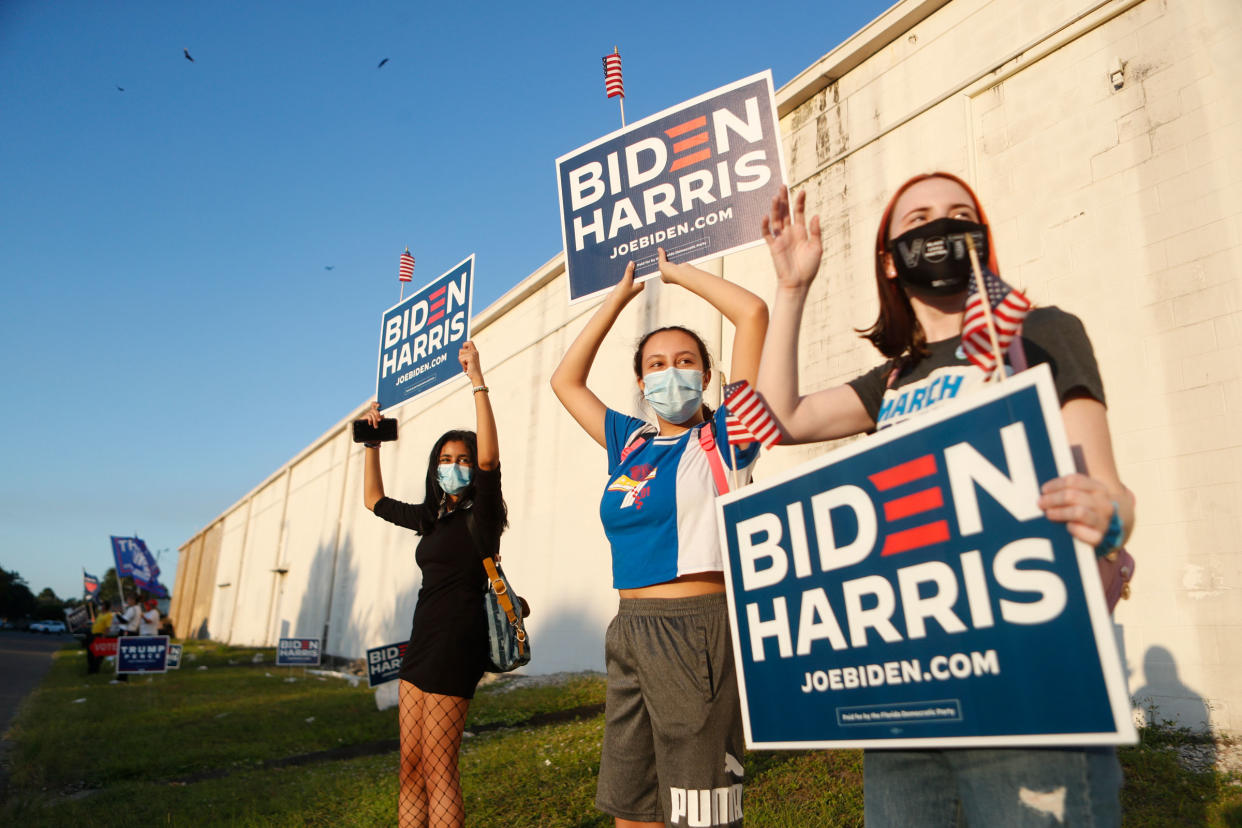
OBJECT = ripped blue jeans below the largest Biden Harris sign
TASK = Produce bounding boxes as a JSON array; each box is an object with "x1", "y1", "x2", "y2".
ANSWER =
[{"x1": 863, "y1": 747, "x2": 1122, "y2": 828}]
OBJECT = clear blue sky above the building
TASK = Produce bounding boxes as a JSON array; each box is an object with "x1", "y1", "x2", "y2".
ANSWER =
[{"x1": 0, "y1": 0, "x2": 889, "y2": 605}]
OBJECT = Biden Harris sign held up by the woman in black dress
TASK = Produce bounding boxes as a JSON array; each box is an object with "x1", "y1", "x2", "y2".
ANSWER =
[{"x1": 375, "y1": 254, "x2": 474, "y2": 411}]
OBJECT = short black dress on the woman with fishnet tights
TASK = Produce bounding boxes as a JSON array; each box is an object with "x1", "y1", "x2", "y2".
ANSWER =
[{"x1": 375, "y1": 468, "x2": 501, "y2": 699}]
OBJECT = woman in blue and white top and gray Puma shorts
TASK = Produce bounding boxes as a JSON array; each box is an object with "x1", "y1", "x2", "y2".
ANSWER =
[{"x1": 551, "y1": 250, "x2": 768, "y2": 826}]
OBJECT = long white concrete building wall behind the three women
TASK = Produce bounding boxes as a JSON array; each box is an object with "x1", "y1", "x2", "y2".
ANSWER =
[{"x1": 175, "y1": 0, "x2": 1242, "y2": 731}]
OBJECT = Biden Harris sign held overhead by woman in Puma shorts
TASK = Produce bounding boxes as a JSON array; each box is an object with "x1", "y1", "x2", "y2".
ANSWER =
[{"x1": 556, "y1": 72, "x2": 785, "y2": 302}]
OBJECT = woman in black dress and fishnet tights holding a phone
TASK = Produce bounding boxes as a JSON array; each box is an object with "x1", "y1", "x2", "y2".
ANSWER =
[{"x1": 363, "y1": 341, "x2": 508, "y2": 826}]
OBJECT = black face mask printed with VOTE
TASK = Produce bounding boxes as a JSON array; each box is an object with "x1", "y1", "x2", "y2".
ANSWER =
[{"x1": 888, "y1": 218, "x2": 987, "y2": 295}]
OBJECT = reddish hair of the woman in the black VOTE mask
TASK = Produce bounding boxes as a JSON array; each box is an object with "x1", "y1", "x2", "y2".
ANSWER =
[{"x1": 858, "y1": 173, "x2": 1000, "y2": 361}]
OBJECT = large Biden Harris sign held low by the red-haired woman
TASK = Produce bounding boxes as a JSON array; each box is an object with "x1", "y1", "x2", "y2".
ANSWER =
[{"x1": 718, "y1": 366, "x2": 1135, "y2": 749}]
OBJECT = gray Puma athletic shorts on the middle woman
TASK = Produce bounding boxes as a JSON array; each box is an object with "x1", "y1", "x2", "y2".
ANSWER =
[{"x1": 595, "y1": 593, "x2": 744, "y2": 826}]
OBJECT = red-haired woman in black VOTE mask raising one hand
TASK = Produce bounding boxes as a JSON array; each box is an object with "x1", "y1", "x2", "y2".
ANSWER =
[{"x1": 759, "y1": 178, "x2": 1134, "y2": 826}]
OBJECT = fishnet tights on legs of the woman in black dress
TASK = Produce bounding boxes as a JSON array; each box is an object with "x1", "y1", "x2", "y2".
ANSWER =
[{"x1": 397, "y1": 679, "x2": 469, "y2": 828}]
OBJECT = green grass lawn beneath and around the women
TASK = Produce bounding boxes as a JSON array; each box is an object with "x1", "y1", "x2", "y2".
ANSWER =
[{"x1": 0, "y1": 643, "x2": 1242, "y2": 828}]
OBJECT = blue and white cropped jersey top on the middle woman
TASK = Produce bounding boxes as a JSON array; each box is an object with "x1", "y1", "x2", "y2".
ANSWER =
[{"x1": 600, "y1": 407, "x2": 759, "y2": 590}]
